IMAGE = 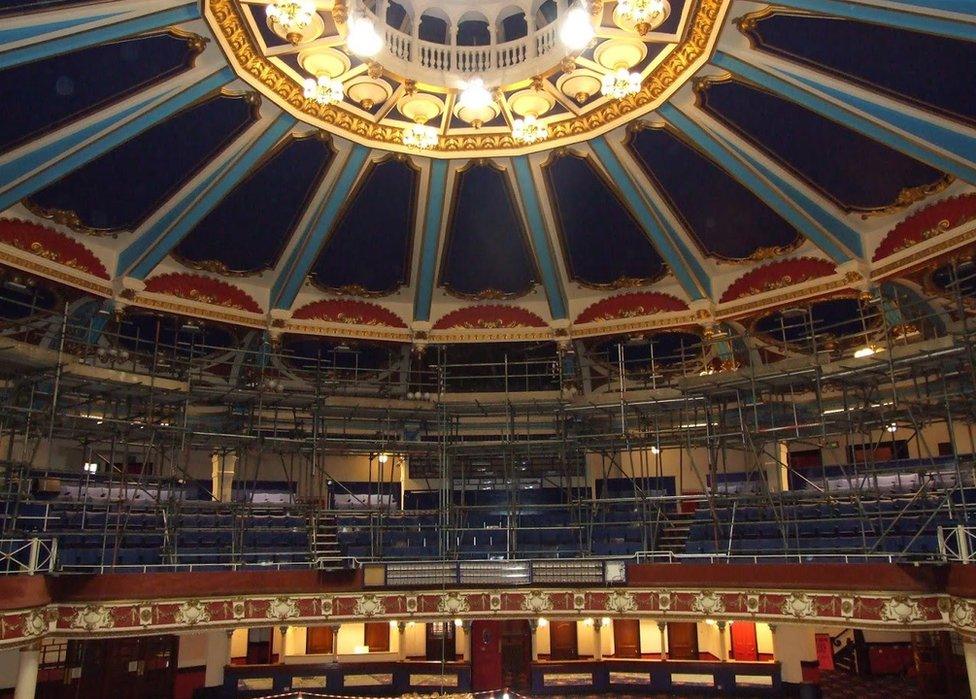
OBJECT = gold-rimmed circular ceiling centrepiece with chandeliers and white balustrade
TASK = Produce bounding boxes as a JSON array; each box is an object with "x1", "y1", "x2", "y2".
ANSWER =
[{"x1": 203, "y1": 0, "x2": 729, "y2": 157}]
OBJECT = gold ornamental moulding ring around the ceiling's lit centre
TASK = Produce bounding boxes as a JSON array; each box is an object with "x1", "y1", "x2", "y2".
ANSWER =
[{"x1": 203, "y1": 0, "x2": 731, "y2": 158}]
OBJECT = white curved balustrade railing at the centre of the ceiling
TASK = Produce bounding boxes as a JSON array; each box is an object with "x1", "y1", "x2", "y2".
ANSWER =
[{"x1": 371, "y1": 7, "x2": 568, "y2": 83}]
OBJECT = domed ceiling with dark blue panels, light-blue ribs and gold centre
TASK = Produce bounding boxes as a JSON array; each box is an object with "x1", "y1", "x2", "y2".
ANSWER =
[{"x1": 0, "y1": 0, "x2": 976, "y2": 342}]
